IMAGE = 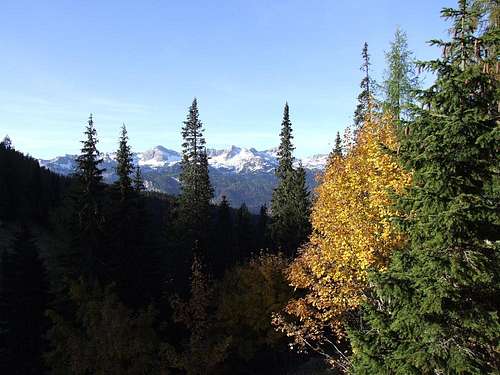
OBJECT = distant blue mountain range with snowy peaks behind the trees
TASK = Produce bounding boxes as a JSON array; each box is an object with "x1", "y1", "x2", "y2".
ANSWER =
[{"x1": 38, "y1": 146, "x2": 328, "y2": 212}]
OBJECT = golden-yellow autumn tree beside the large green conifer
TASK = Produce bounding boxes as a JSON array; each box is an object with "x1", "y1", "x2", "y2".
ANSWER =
[{"x1": 273, "y1": 114, "x2": 410, "y2": 366}]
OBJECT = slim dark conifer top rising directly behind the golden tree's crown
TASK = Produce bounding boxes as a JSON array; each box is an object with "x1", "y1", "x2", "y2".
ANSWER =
[{"x1": 354, "y1": 42, "x2": 375, "y2": 136}]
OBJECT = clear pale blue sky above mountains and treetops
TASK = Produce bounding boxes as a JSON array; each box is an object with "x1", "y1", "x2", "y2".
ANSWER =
[{"x1": 0, "y1": 0, "x2": 456, "y2": 158}]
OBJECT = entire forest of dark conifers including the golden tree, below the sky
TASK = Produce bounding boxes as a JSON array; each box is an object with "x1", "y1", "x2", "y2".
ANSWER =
[{"x1": 0, "y1": 0, "x2": 500, "y2": 375}]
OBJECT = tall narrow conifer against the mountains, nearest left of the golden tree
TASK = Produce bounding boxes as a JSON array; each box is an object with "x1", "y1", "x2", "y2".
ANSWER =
[{"x1": 270, "y1": 103, "x2": 310, "y2": 255}]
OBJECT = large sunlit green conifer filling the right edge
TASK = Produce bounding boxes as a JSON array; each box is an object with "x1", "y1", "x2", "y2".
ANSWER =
[{"x1": 351, "y1": 0, "x2": 500, "y2": 374}]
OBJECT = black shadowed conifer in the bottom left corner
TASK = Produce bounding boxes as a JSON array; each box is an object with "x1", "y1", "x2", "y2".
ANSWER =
[{"x1": 0, "y1": 226, "x2": 48, "y2": 375}]
